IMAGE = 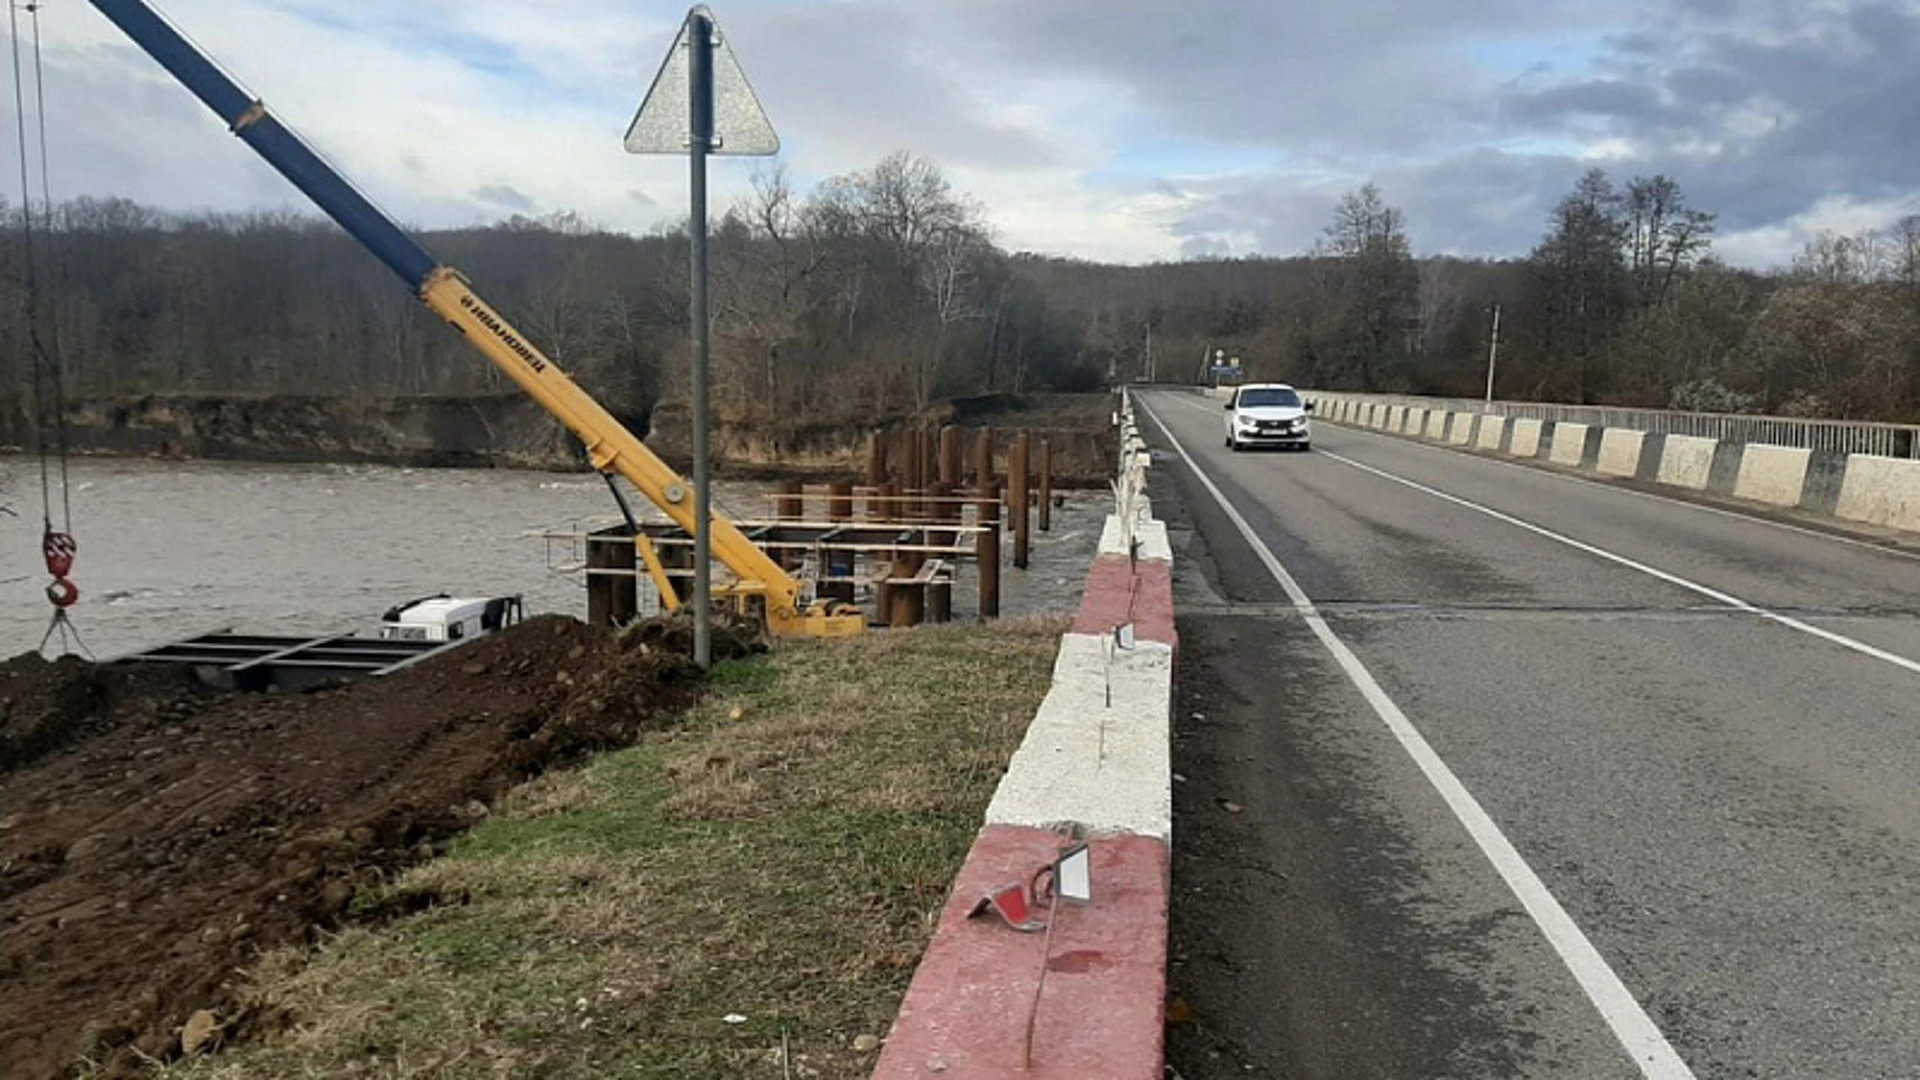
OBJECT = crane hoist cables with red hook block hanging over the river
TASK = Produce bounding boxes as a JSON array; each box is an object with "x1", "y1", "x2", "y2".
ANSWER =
[{"x1": 8, "y1": 0, "x2": 92, "y2": 655}]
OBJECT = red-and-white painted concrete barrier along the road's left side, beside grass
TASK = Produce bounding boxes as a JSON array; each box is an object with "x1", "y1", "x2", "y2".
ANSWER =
[{"x1": 872, "y1": 386, "x2": 1179, "y2": 1080}]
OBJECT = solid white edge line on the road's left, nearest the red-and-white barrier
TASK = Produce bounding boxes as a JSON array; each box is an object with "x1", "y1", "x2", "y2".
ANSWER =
[{"x1": 1142, "y1": 393, "x2": 1695, "y2": 1080}]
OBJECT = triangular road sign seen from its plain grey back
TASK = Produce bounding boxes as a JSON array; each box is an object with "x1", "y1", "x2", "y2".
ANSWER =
[{"x1": 626, "y1": 6, "x2": 780, "y2": 158}]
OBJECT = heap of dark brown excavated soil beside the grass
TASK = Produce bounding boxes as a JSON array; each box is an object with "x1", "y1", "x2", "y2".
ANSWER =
[{"x1": 0, "y1": 617, "x2": 756, "y2": 1080}]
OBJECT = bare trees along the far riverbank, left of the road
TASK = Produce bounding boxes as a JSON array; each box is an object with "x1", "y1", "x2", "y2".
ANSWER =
[{"x1": 0, "y1": 154, "x2": 1104, "y2": 421}]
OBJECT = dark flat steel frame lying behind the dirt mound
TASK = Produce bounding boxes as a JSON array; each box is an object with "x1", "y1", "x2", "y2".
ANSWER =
[{"x1": 117, "y1": 630, "x2": 465, "y2": 692}]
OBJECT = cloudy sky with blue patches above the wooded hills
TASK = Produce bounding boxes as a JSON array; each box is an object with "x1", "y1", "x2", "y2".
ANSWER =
[{"x1": 11, "y1": 0, "x2": 1920, "y2": 267}]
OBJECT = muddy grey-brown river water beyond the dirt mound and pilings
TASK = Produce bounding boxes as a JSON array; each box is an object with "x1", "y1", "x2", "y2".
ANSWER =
[{"x1": 0, "y1": 457, "x2": 1108, "y2": 659}]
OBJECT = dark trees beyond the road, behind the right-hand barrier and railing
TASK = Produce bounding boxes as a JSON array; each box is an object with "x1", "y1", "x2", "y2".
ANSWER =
[{"x1": 1039, "y1": 169, "x2": 1920, "y2": 421}]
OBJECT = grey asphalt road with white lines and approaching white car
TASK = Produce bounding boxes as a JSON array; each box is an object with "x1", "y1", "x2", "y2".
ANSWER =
[{"x1": 1139, "y1": 392, "x2": 1920, "y2": 1080}]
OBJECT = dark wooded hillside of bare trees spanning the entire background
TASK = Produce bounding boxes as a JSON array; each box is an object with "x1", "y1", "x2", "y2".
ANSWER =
[{"x1": 0, "y1": 154, "x2": 1920, "y2": 423}]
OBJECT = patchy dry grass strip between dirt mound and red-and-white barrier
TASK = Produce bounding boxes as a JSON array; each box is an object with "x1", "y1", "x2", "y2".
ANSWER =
[{"x1": 165, "y1": 619, "x2": 1066, "y2": 1080}]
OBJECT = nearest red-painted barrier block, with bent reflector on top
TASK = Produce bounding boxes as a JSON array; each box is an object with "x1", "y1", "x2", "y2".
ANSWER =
[{"x1": 874, "y1": 824, "x2": 1169, "y2": 1080}]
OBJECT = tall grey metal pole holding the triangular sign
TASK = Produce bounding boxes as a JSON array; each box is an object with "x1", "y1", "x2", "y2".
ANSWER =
[{"x1": 687, "y1": 10, "x2": 714, "y2": 667}]
